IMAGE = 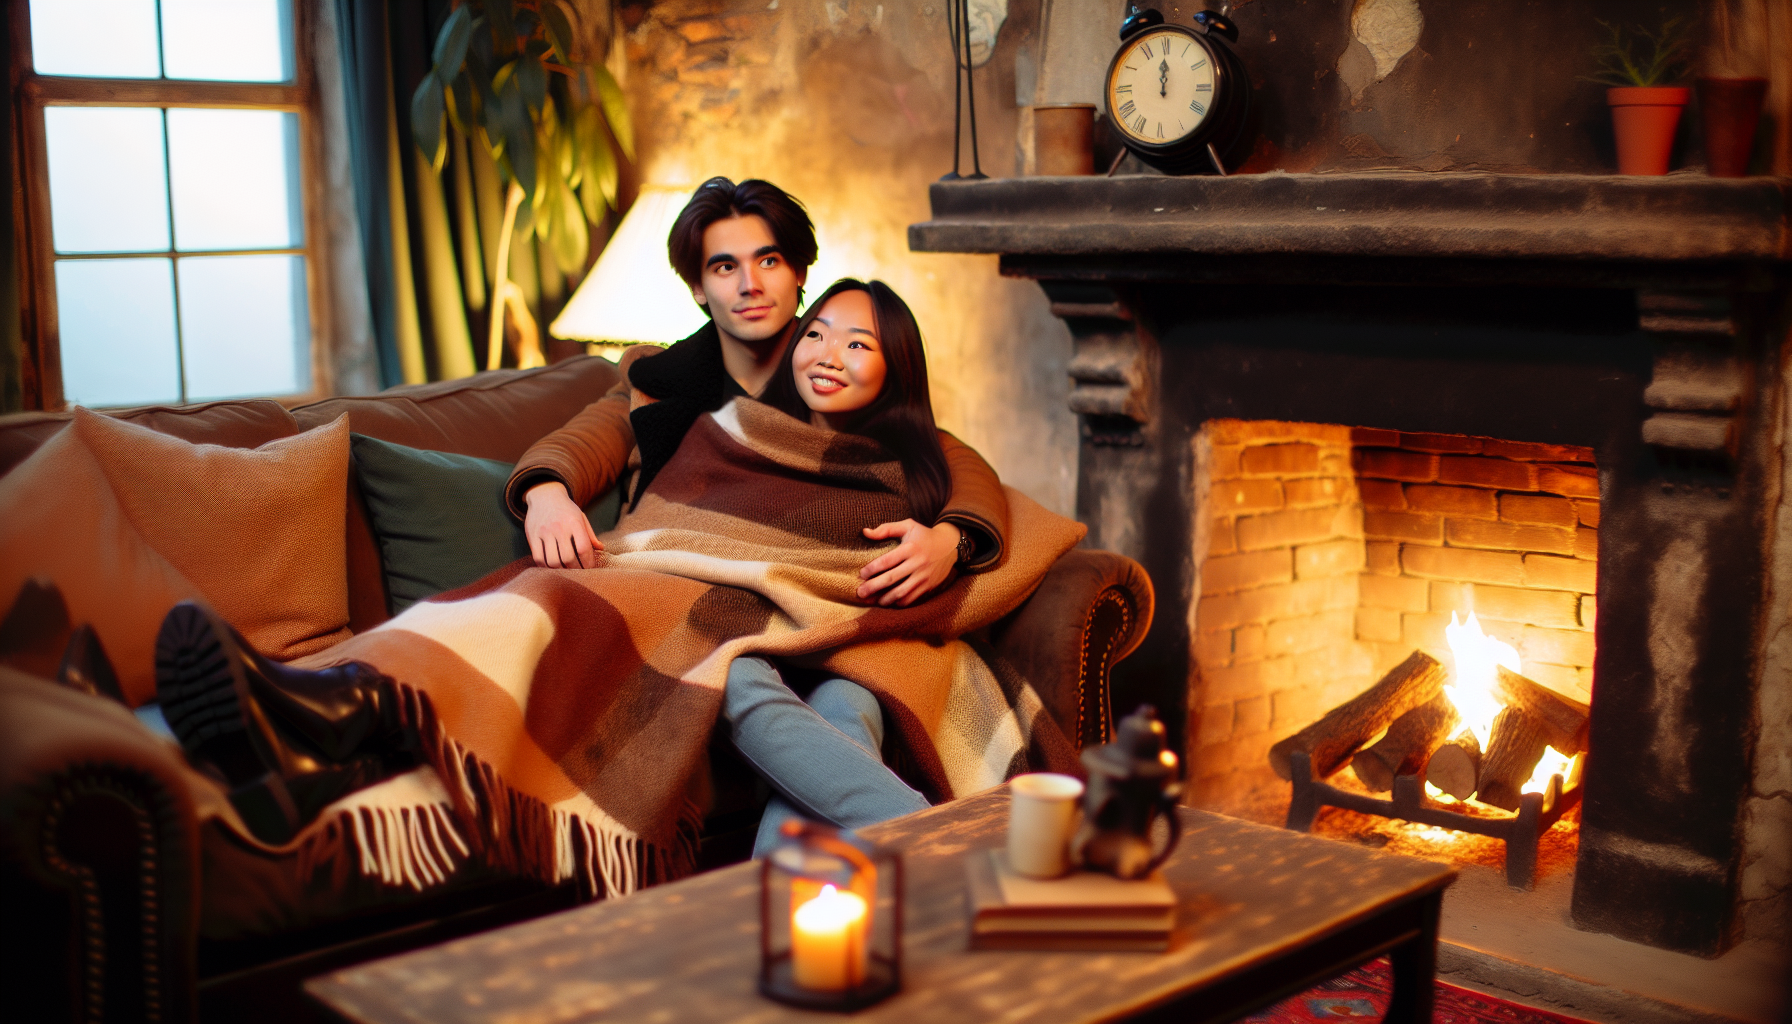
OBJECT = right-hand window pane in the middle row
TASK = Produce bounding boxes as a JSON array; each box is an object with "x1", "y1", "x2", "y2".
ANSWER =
[{"x1": 168, "y1": 109, "x2": 303, "y2": 251}]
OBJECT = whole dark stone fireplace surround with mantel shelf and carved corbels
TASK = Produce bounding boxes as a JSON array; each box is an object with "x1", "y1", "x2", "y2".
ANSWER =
[{"x1": 909, "y1": 172, "x2": 1792, "y2": 956}]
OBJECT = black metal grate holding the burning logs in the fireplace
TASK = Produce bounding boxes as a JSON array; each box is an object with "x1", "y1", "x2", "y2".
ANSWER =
[{"x1": 1288, "y1": 751, "x2": 1581, "y2": 889}]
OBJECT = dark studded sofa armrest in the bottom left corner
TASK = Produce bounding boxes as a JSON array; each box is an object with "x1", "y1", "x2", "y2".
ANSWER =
[{"x1": 0, "y1": 669, "x2": 199, "y2": 1020}]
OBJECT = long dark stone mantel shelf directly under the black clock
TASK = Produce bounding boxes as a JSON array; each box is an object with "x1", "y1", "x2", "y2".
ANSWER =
[{"x1": 909, "y1": 172, "x2": 1792, "y2": 276}]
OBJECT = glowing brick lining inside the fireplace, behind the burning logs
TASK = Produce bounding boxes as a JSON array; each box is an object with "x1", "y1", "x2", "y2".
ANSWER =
[{"x1": 1190, "y1": 420, "x2": 1598, "y2": 811}]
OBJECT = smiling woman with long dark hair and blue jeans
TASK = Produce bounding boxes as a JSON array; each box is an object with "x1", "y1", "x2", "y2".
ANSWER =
[{"x1": 722, "y1": 278, "x2": 950, "y2": 857}]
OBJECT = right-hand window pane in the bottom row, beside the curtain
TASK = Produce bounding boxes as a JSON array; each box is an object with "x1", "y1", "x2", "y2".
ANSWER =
[{"x1": 181, "y1": 256, "x2": 312, "y2": 402}]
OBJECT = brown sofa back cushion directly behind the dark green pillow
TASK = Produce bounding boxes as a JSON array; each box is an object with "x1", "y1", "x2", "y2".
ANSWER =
[{"x1": 292, "y1": 355, "x2": 620, "y2": 463}]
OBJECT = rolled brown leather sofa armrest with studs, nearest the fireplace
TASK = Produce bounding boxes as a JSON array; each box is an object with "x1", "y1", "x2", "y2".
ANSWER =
[{"x1": 989, "y1": 547, "x2": 1156, "y2": 750}]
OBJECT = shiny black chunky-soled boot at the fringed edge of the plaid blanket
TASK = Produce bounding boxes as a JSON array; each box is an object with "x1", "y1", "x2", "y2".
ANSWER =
[{"x1": 156, "y1": 603, "x2": 414, "y2": 845}]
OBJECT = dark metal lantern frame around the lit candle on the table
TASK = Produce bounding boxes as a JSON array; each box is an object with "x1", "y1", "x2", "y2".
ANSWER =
[{"x1": 758, "y1": 820, "x2": 905, "y2": 1011}]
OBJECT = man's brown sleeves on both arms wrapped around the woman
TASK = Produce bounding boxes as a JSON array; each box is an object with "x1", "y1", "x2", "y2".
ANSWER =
[{"x1": 504, "y1": 342, "x2": 1009, "y2": 572}]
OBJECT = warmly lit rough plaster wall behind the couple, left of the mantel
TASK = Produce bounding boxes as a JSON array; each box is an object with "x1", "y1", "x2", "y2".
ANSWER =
[{"x1": 620, "y1": 0, "x2": 1077, "y2": 515}]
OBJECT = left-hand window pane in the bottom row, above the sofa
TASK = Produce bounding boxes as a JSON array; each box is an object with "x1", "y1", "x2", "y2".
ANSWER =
[{"x1": 56, "y1": 256, "x2": 181, "y2": 405}]
